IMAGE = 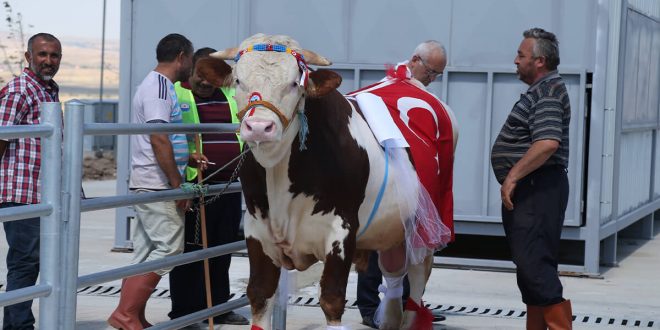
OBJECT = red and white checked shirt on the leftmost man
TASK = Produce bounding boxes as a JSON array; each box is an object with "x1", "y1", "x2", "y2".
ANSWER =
[{"x1": 0, "y1": 68, "x2": 59, "y2": 204}]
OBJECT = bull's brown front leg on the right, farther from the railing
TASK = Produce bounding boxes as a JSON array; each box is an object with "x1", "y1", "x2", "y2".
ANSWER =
[{"x1": 321, "y1": 235, "x2": 355, "y2": 330}]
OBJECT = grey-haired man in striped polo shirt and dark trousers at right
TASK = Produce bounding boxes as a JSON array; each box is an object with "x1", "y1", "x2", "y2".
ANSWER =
[{"x1": 491, "y1": 28, "x2": 572, "y2": 329}]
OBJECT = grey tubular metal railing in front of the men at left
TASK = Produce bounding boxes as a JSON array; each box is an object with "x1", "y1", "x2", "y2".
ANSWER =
[{"x1": 0, "y1": 101, "x2": 288, "y2": 330}]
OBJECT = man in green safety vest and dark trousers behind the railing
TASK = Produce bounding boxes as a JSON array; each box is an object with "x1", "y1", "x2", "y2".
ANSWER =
[{"x1": 169, "y1": 48, "x2": 249, "y2": 325}]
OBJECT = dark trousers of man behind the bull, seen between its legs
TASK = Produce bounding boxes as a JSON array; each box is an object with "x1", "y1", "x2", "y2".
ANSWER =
[{"x1": 356, "y1": 252, "x2": 410, "y2": 317}]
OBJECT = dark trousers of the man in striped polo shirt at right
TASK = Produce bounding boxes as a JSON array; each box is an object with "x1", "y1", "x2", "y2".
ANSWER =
[{"x1": 502, "y1": 166, "x2": 568, "y2": 306}]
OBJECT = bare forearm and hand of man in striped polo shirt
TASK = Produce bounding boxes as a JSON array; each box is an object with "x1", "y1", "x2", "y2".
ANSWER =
[{"x1": 500, "y1": 139, "x2": 559, "y2": 211}]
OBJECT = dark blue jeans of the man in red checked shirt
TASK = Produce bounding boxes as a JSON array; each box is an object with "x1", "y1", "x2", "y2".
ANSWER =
[{"x1": 0, "y1": 203, "x2": 40, "y2": 330}]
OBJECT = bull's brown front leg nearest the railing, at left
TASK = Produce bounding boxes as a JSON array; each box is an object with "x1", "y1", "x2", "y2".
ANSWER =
[{"x1": 245, "y1": 238, "x2": 280, "y2": 330}]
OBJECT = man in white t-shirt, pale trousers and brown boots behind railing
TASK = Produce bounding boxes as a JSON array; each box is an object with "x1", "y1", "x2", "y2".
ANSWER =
[{"x1": 108, "y1": 34, "x2": 193, "y2": 329}]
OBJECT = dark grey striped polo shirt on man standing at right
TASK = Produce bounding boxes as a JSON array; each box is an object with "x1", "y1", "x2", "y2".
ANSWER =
[{"x1": 490, "y1": 71, "x2": 571, "y2": 183}]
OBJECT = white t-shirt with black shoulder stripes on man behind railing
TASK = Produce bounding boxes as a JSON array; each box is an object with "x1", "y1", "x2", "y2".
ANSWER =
[{"x1": 129, "y1": 71, "x2": 188, "y2": 189}]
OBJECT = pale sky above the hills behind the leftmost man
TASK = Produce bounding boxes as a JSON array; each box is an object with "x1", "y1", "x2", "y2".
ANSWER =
[{"x1": 0, "y1": 0, "x2": 121, "y2": 40}]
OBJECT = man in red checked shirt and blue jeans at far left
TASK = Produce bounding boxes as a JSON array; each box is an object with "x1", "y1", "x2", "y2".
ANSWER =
[{"x1": 0, "y1": 33, "x2": 62, "y2": 329}]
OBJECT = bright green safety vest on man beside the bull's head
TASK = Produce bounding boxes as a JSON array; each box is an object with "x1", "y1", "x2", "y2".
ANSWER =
[{"x1": 174, "y1": 81, "x2": 243, "y2": 181}]
